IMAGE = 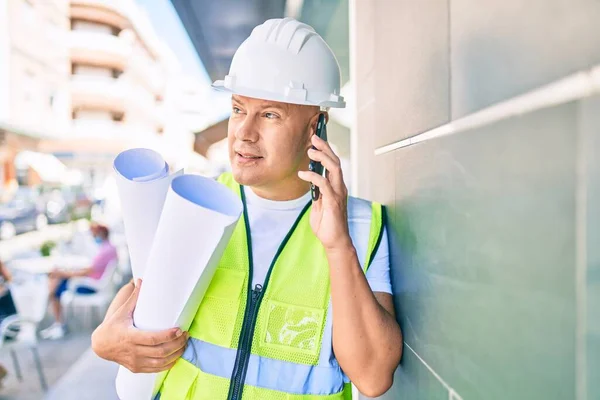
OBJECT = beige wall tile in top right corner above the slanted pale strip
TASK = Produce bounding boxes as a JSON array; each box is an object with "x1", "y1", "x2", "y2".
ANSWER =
[{"x1": 450, "y1": 0, "x2": 600, "y2": 119}]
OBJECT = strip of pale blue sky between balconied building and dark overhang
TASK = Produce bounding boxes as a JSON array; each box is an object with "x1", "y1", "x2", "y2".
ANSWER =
[{"x1": 136, "y1": 0, "x2": 210, "y2": 83}]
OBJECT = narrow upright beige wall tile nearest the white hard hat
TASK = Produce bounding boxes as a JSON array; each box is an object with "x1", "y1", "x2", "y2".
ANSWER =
[{"x1": 370, "y1": 0, "x2": 450, "y2": 147}]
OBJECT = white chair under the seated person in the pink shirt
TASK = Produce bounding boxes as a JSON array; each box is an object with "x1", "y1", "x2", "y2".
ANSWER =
[{"x1": 60, "y1": 259, "x2": 118, "y2": 328}]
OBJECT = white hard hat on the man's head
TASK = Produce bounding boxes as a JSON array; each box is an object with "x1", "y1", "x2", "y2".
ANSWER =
[{"x1": 212, "y1": 18, "x2": 346, "y2": 108}]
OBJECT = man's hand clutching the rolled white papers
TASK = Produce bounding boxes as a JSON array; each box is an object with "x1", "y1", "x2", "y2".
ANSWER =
[{"x1": 92, "y1": 281, "x2": 188, "y2": 373}]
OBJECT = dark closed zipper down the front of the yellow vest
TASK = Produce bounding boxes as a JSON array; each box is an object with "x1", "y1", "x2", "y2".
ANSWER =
[{"x1": 228, "y1": 284, "x2": 264, "y2": 400}]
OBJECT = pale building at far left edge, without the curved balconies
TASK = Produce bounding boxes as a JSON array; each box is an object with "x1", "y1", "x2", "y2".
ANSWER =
[{"x1": 0, "y1": 0, "x2": 71, "y2": 190}]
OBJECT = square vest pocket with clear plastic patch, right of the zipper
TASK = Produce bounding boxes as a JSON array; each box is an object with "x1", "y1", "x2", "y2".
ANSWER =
[{"x1": 261, "y1": 300, "x2": 325, "y2": 364}]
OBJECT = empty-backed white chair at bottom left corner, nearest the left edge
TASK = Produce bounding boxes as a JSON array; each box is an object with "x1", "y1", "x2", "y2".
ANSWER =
[{"x1": 0, "y1": 275, "x2": 48, "y2": 391}]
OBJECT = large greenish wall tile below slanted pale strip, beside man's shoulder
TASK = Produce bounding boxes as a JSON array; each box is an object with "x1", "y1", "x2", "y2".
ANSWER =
[{"x1": 392, "y1": 104, "x2": 577, "y2": 400}]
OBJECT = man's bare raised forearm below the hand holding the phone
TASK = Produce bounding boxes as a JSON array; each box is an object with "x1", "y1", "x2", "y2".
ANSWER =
[{"x1": 327, "y1": 243, "x2": 402, "y2": 397}]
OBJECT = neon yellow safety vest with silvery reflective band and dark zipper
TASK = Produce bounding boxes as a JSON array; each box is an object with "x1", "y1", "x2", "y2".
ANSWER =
[{"x1": 160, "y1": 174, "x2": 385, "y2": 400}]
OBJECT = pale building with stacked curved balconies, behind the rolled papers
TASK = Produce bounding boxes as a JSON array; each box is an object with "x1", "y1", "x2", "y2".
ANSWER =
[{"x1": 40, "y1": 0, "x2": 172, "y2": 179}]
